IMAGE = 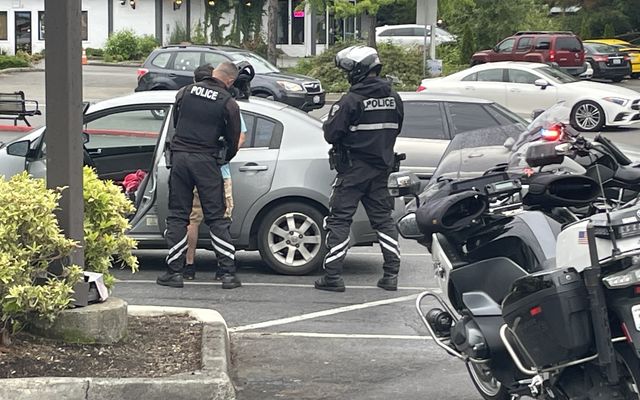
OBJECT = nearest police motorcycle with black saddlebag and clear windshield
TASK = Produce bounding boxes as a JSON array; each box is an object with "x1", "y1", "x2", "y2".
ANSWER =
[{"x1": 389, "y1": 115, "x2": 640, "y2": 400}]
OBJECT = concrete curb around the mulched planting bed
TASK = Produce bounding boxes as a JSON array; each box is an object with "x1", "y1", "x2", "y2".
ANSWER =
[{"x1": 0, "y1": 306, "x2": 236, "y2": 400}]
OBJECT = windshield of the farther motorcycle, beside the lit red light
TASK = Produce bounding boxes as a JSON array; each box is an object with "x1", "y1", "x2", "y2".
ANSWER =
[{"x1": 509, "y1": 101, "x2": 571, "y2": 173}]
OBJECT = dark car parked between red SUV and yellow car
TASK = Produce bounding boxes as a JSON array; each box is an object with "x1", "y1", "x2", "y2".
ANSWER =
[{"x1": 584, "y1": 43, "x2": 631, "y2": 82}]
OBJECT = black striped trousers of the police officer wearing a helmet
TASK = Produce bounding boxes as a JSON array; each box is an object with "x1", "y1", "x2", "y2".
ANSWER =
[{"x1": 323, "y1": 160, "x2": 400, "y2": 278}]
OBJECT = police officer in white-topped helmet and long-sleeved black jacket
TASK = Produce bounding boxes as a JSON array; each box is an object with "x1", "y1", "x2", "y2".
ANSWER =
[{"x1": 315, "y1": 46, "x2": 404, "y2": 292}]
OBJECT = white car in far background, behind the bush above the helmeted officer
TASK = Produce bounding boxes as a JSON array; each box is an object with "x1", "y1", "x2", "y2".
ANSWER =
[{"x1": 376, "y1": 24, "x2": 456, "y2": 46}]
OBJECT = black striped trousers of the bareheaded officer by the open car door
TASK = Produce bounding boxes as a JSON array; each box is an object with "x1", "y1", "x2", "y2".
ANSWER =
[{"x1": 166, "y1": 152, "x2": 236, "y2": 274}]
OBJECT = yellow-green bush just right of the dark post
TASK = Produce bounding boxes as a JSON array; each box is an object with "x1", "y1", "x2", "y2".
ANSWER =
[{"x1": 83, "y1": 167, "x2": 138, "y2": 287}]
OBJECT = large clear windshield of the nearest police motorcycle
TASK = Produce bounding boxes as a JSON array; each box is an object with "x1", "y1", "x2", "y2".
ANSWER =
[{"x1": 428, "y1": 124, "x2": 525, "y2": 186}]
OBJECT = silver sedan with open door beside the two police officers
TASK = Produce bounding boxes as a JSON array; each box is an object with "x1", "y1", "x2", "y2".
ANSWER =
[{"x1": 0, "y1": 91, "x2": 404, "y2": 275}]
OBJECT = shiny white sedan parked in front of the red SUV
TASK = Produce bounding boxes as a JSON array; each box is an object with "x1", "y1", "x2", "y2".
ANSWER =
[{"x1": 418, "y1": 61, "x2": 640, "y2": 132}]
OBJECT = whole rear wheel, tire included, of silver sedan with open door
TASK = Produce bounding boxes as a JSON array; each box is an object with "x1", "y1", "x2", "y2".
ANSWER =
[{"x1": 258, "y1": 202, "x2": 327, "y2": 275}]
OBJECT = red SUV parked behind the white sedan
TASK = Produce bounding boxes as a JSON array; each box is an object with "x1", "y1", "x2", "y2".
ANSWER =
[{"x1": 471, "y1": 31, "x2": 587, "y2": 76}]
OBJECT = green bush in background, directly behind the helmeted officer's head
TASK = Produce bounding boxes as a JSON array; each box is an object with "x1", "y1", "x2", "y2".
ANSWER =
[{"x1": 292, "y1": 42, "x2": 423, "y2": 92}]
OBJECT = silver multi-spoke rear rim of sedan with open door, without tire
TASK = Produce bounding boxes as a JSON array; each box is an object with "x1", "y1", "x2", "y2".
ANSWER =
[{"x1": 268, "y1": 212, "x2": 322, "y2": 267}]
